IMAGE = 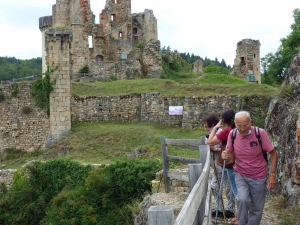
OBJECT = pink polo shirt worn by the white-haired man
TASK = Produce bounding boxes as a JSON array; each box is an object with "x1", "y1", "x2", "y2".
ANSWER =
[{"x1": 227, "y1": 126, "x2": 274, "y2": 179}]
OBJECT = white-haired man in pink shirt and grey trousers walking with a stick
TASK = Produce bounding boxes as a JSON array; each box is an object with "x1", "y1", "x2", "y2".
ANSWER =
[{"x1": 222, "y1": 111, "x2": 278, "y2": 225}]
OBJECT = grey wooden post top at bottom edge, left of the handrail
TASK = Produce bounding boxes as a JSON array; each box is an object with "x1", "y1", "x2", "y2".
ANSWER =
[{"x1": 148, "y1": 205, "x2": 174, "y2": 225}]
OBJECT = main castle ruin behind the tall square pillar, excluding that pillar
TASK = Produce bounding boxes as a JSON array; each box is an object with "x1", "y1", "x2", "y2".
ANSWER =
[{"x1": 39, "y1": 0, "x2": 161, "y2": 79}]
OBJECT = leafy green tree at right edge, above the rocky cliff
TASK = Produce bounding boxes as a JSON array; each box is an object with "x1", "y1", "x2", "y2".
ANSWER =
[{"x1": 261, "y1": 9, "x2": 300, "y2": 85}]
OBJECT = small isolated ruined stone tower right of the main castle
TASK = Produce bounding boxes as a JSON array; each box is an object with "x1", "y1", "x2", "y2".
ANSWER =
[{"x1": 232, "y1": 39, "x2": 261, "y2": 84}]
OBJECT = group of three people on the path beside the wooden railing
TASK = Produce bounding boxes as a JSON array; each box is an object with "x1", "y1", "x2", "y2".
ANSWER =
[{"x1": 203, "y1": 109, "x2": 278, "y2": 225}]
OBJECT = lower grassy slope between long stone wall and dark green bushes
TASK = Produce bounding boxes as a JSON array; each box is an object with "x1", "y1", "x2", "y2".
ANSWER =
[{"x1": 1, "y1": 123, "x2": 209, "y2": 168}]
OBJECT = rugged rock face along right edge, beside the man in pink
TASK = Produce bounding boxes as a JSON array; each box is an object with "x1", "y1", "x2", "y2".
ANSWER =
[{"x1": 266, "y1": 53, "x2": 300, "y2": 205}]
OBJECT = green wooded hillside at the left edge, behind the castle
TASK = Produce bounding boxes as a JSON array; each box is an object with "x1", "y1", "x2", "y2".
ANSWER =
[{"x1": 0, "y1": 57, "x2": 42, "y2": 80}]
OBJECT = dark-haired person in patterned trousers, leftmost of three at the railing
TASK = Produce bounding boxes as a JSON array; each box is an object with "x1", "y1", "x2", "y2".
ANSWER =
[{"x1": 202, "y1": 115, "x2": 235, "y2": 218}]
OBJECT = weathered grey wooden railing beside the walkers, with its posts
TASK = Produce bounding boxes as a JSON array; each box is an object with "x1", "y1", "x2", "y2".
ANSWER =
[{"x1": 148, "y1": 137, "x2": 211, "y2": 225}]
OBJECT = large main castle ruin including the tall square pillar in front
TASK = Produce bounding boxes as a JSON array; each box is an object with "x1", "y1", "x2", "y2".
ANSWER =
[{"x1": 39, "y1": 0, "x2": 162, "y2": 142}]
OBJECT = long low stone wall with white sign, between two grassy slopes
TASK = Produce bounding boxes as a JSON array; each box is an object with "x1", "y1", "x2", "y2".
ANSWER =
[{"x1": 71, "y1": 93, "x2": 267, "y2": 129}]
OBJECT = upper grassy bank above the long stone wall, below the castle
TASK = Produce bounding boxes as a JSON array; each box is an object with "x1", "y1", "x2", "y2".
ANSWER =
[{"x1": 72, "y1": 73, "x2": 279, "y2": 97}]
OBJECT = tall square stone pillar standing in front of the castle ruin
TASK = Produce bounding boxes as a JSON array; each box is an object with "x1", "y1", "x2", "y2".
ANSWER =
[{"x1": 46, "y1": 29, "x2": 72, "y2": 147}]
